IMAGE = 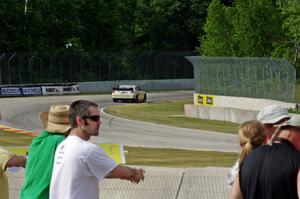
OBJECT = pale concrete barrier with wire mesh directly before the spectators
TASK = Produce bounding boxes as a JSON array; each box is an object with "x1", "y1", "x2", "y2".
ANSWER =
[{"x1": 7, "y1": 168, "x2": 229, "y2": 199}]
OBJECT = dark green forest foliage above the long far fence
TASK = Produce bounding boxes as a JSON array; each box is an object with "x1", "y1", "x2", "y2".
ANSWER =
[{"x1": 0, "y1": 0, "x2": 210, "y2": 52}]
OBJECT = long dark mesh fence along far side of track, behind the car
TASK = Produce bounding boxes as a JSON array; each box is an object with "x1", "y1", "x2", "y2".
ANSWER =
[{"x1": 0, "y1": 52, "x2": 197, "y2": 85}]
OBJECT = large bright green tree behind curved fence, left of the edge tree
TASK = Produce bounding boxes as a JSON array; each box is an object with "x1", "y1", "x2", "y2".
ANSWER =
[{"x1": 201, "y1": 0, "x2": 283, "y2": 57}]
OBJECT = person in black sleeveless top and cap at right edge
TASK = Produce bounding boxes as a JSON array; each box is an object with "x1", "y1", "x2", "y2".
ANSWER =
[{"x1": 230, "y1": 115, "x2": 300, "y2": 199}]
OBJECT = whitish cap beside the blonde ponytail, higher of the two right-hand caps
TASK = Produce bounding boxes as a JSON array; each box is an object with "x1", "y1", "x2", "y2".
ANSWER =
[{"x1": 256, "y1": 104, "x2": 291, "y2": 124}]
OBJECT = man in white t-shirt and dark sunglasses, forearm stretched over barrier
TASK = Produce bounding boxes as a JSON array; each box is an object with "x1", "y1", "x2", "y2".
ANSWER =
[{"x1": 50, "y1": 100, "x2": 144, "y2": 199}]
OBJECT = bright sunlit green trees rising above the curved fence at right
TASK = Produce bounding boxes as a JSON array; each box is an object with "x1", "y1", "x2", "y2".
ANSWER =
[{"x1": 199, "y1": 0, "x2": 300, "y2": 74}]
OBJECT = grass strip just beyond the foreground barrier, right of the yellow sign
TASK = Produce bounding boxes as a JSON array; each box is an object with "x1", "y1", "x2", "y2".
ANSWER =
[{"x1": 124, "y1": 146, "x2": 238, "y2": 168}]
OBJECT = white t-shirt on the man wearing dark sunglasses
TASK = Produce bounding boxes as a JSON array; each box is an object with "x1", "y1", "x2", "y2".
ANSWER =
[{"x1": 50, "y1": 135, "x2": 117, "y2": 199}]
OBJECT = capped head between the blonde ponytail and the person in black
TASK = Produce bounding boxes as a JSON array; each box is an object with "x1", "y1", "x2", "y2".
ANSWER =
[{"x1": 256, "y1": 104, "x2": 291, "y2": 140}]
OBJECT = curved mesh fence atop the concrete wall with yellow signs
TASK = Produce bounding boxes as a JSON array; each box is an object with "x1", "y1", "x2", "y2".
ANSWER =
[{"x1": 187, "y1": 56, "x2": 296, "y2": 102}]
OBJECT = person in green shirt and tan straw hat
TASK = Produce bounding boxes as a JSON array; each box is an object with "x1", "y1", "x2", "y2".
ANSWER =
[{"x1": 20, "y1": 105, "x2": 71, "y2": 199}]
